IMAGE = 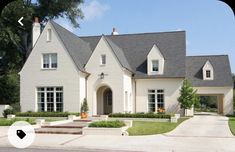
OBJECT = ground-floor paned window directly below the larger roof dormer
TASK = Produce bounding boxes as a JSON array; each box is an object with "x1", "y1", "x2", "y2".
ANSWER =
[{"x1": 148, "y1": 89, "x2": 164, "y2": 112}]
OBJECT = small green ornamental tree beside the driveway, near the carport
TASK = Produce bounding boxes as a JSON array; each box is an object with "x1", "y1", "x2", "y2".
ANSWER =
[{"x1": 178, "y1": 80, "x2": 199, "y2": 113}]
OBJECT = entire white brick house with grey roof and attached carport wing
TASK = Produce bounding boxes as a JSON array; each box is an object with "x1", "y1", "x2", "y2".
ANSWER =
[{"x1": 20, "y1": 21, "x2": 233, "y2": 115}]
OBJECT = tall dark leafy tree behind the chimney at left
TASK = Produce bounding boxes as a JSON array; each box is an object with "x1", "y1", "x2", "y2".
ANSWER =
[{"x1": 0, "y1": 0, "x2": 83, "y2": 103}]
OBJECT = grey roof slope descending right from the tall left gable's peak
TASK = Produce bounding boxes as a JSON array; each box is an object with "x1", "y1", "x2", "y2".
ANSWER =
[{"x1": 49, "y1": 21, "x2": 92, "y2": 72}]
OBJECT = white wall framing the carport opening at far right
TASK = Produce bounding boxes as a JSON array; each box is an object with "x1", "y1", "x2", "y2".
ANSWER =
[{"x1": 194, "y1": 87, "x2": 233, "y2": 115}]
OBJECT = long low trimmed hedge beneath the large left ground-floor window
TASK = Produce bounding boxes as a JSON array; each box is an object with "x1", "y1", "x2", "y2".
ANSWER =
[{"x1": 16, "y1": 112, "x2": 79, "y2": 117}]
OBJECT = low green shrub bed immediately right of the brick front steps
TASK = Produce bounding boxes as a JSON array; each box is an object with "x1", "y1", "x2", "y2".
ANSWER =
[{"x1": 89, "y1": 120, "x2": 125, "y2": 128}]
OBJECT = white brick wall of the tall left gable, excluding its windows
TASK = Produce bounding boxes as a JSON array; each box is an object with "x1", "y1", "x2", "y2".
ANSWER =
[{"x1": 20, "y1": 23, "x2": 85, "y2": 112}]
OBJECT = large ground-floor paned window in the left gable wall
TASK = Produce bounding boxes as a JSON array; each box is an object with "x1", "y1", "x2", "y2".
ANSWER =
[{"x1": 37, "y1": 87, "x2": 63, "y2": 112}]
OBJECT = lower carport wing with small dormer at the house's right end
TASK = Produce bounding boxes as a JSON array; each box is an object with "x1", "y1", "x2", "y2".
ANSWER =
[{"x1": 186, "y1": 55, "x2": 233, "y2": 115}]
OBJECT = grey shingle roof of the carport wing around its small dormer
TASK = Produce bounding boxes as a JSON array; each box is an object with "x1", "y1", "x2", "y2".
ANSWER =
[{"x1": 186, "y1": 55, "x2": 233, "y2": 87}]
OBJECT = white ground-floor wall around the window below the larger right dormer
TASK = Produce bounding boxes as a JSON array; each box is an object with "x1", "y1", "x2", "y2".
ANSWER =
[{"x1": 136, "y1": 79, "x2": 183, "y2": 113}]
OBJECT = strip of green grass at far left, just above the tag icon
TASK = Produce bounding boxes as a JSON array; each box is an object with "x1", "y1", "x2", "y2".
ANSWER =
[{"x1": 0, "y1": 118, "x2": 35, "y2": 126}]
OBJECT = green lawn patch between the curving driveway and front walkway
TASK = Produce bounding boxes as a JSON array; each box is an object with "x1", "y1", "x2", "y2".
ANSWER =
[{"x1": 127, "y1": 117, "x2": 189, "y2": 136}]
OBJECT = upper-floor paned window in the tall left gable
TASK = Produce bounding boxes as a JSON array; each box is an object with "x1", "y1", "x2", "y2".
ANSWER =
[{"x1": 42, "y1": 53, "x2": 57, "y2": 69}]
